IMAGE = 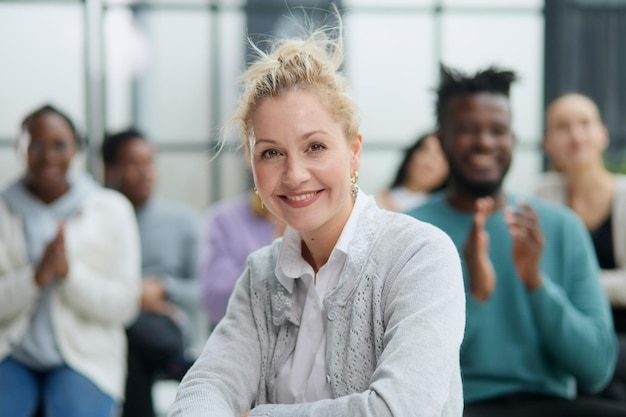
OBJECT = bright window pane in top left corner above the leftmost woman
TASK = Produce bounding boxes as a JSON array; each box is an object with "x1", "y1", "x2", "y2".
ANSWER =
[{"x1": 0, "y1": 3, "x2": 85, "y2": 138}]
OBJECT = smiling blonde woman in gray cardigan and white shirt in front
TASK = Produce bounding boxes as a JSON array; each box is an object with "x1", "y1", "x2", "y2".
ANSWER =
[{"x1": 169, "y1": 12, "x2": 465, "y2": 417}]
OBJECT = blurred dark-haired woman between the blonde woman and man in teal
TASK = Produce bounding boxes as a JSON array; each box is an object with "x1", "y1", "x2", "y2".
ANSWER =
[{"x1": 378, "y1": 132, "x2": 449, "y2": 211}]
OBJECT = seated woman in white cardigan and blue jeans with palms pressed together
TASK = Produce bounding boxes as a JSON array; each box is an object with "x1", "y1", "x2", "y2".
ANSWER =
[{"x1": 0, "y1": 105, "x2": 141, "y2": 417}]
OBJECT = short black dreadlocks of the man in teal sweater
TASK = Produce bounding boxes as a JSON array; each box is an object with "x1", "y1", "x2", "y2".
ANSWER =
[{"x1": 436, "y1": 64, "x2": 518, "y2": 129}]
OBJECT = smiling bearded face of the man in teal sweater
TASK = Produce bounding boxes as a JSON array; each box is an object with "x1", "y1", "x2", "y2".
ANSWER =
[{"x1": 441, "y1": 93, "x2": 515, "y2": 197}]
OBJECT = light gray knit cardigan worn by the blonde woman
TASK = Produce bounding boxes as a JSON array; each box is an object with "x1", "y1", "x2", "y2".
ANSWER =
[{"x1": 169, "y1": 197, "x2": 465, "y2": 417}]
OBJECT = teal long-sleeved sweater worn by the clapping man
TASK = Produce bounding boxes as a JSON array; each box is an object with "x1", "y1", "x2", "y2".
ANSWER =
[{"x1": 409, "y1": 193, "x2": 617, "y2": 403}]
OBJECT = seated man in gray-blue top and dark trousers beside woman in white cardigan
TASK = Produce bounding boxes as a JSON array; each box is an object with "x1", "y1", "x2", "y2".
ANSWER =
[{"x1": 102, "y1": 129, "x2": 199, "y2": 417}]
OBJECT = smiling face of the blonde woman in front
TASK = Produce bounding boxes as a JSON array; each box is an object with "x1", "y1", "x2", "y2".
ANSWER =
[{"x1": 250, "y1": 90, "x2": 361, "y2": 237}]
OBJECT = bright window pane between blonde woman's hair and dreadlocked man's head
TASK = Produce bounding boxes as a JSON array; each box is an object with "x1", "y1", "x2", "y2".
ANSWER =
[{"x1": 345, "y1": 13, "x2": 436, "y2": 144}]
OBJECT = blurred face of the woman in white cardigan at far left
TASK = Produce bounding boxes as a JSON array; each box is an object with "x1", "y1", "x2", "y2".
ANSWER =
[{"x1": 26, "y1": 113, "x2": 76, "y2": 188}]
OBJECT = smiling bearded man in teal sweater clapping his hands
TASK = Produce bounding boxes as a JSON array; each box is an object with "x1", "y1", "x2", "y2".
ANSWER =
[{"x1": 409, "y1": 66, "x2": 626, "y2": 417}]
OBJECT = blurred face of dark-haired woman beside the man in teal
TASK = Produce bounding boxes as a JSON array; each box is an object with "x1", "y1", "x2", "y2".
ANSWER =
[{"x1": 405, "y1": 135, "x2": 449, "y2": 192}]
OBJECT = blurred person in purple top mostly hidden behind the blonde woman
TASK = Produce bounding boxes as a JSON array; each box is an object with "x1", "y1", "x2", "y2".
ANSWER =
[{"x1": 200, "y1": 190, "x2": 285, "y2": 328}]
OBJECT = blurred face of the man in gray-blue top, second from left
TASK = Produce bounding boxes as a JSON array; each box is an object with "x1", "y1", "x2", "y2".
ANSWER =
[{"x1": 106, "y1": 138, "x2": 155, "y2": 207}]
